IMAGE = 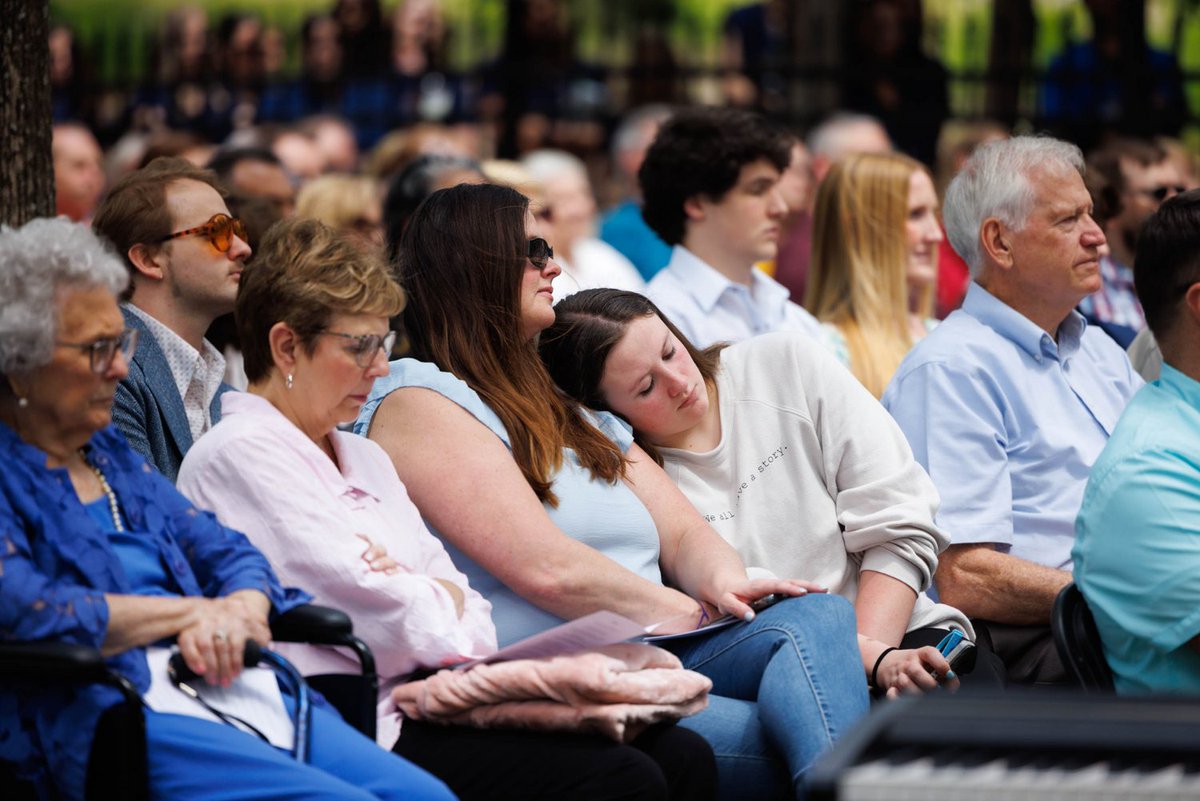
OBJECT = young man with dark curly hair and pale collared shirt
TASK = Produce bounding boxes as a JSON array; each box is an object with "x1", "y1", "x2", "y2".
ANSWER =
[{"x1": 638, "y1": 108, "x2": 817, "y2": 348}]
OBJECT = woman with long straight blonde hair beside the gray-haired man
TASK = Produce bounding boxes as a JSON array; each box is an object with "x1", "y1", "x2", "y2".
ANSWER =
[{"x1": 804, "y1": 153, "x2": 942, "y2": 398}]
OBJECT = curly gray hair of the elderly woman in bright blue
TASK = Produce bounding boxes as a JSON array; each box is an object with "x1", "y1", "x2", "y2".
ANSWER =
[{"x1": 0, "y1": 217, "x2": 130, "y2": 375}]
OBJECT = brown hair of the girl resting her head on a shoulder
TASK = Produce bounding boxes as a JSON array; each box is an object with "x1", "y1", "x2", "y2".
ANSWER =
[{"x1": 538, "y1": 289, "x2": 726, "y2": 464}]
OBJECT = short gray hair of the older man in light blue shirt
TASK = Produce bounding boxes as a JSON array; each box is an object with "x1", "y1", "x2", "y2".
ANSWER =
[{"x1": 942, "y1": 135, "x2": 1084, "y2": 278}]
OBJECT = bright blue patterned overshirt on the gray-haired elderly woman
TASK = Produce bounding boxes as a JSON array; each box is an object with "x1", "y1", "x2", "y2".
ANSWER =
[{"x1": 0, "y1": 423, "x2": 310, "y2": 797}]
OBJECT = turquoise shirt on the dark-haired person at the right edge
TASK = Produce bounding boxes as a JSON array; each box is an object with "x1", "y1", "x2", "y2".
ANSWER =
[{"x1": 1072, "y1": 365, "x2": 1200, "y2": 693}]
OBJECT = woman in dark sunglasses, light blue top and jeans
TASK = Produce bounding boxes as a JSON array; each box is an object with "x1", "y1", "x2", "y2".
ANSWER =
[{"x1": 356, "y1": 185, "x2": 866, "y2": 799}]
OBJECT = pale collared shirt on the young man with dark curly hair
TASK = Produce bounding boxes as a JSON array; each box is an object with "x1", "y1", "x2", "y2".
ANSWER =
[{"x1": 646, "y1": 245, "x2": 821, "y2": 348}]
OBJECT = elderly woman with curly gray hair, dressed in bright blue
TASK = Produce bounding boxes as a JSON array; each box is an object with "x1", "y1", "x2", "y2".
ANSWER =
[{"x1": 0, "y1": 218, "x2": 454, "y2": 801}]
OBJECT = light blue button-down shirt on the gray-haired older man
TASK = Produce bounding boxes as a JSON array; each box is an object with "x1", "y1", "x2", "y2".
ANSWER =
[{"x1": 882, "y1": 282, "x2": 1142, "y2": 570}]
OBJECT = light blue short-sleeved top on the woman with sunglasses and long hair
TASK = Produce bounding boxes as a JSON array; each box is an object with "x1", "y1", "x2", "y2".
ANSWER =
[{"x1": 354, "y1": 359, "x2": 662, "y2": 648}]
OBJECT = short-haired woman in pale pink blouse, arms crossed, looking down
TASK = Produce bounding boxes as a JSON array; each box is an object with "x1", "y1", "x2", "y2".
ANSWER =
[{"x1": 179, "y1": 219, "x2": 714, "y2": 799}]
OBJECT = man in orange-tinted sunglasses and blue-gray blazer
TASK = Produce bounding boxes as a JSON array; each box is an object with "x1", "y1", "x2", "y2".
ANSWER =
[{"x1": 92, "y1": 158, "x2": 251, "y2": 481}]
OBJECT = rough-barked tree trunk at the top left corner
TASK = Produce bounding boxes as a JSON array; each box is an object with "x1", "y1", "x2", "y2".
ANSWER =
[{"x1": 0, "y1": 0, "x2": 54, "y2": 225}]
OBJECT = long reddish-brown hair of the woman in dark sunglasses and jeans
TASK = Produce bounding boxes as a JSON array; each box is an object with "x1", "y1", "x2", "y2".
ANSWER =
[{"x1": 397, "y1": 183, "x2": 626, "y2": 506}]
